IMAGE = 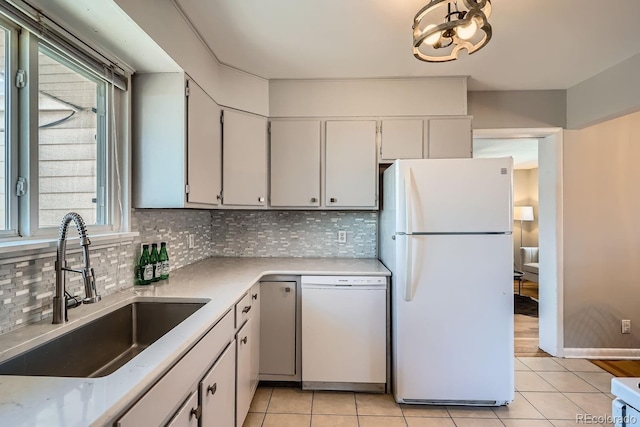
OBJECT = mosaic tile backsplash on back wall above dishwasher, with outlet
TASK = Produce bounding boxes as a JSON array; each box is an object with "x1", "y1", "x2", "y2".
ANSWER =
[{"x1": 211, "y1": 210, "x2": 378, "y2": 258}]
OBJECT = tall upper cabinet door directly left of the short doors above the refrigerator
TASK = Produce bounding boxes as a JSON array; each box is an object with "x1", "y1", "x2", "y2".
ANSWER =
[{"x1": 325, "y1": 120, "x2": 378, "y2": 208}]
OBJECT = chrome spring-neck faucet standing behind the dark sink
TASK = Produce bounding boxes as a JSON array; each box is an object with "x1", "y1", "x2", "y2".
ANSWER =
[{"x1": 53, "y1": 212, "x2": 100, "y2": 324}]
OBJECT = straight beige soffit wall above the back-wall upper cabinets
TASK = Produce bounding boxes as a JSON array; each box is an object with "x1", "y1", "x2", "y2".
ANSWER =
[{"x1": 269, "y1": 77, "x2": 467, "y2": 117}]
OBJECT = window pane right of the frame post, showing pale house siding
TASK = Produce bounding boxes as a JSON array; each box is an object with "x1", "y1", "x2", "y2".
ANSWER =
[{"x1": 38, "y1": 46, "x2": 107, "y2": 228}]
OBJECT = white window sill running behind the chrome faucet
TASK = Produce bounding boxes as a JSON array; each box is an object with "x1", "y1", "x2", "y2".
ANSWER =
[{"x1": 0, "y1": 232, "x2": 140, "y2": 260}]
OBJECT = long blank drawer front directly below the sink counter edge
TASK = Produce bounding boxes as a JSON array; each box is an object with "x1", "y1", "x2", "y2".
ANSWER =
[{"x1": 117, "y1": 311, "x2": 234, "y2": 427}]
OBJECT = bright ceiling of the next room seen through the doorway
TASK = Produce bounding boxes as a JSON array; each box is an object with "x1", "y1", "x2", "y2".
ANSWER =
[{"x1": 473, "y1": 138, "x2": 538, "y2": 169}]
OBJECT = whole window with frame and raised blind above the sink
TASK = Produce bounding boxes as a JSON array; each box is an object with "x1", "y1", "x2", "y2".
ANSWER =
[{"x1": 0, "y1": 10, "x2": 126, "y2": 239}]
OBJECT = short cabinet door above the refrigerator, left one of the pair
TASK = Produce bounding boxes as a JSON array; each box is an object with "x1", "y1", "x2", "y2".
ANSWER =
[{"x1": 380, "y1": 119, "x2": 423, "y2": 160}]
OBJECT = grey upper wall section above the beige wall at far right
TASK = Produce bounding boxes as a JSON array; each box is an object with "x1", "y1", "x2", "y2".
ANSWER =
[{"x1": 567, "y1": 54, "x2": 640, "y2": 129}]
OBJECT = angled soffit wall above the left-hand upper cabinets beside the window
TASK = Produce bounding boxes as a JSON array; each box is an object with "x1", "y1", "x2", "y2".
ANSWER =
[{"x1": 115, "y1": 0, "x2": 269, "y2": 116}]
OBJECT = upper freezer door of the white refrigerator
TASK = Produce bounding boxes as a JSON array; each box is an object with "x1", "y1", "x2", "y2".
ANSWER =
[{"x1": 395, "y1": 157, "x2": 513, "y2": 234}]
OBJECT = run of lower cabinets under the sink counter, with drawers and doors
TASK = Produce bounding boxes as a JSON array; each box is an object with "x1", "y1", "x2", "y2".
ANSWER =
[{"x1": 115, "y1": 283, "x2": 261, "y2": 427}]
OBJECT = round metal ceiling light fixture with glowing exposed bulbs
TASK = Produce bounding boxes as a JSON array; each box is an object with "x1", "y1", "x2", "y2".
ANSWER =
[{"x1": 413, "y1": 0, "x2": 491, "y2": 62}]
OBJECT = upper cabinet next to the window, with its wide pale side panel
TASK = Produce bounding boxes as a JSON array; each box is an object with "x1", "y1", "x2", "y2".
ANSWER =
[{"x1": 131, "y1": 73, "x2": 221, "y2": 208}]
